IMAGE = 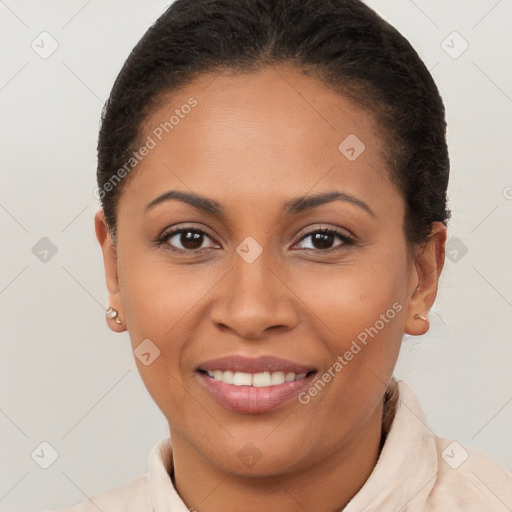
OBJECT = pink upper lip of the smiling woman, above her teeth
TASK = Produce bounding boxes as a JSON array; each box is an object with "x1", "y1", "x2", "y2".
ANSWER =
[{"x1": 197, "y1": 355, "x2": 316, "y2": 374}]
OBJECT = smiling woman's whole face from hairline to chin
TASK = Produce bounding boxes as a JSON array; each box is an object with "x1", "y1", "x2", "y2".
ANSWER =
[{"x1": 96, "y1": 67, "x2": 444, "y2": 475}]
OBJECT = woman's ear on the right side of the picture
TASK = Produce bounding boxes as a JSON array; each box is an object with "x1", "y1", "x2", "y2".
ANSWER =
[{"x1": 404, "y1": 222, "x2": 446, "y2": 336}]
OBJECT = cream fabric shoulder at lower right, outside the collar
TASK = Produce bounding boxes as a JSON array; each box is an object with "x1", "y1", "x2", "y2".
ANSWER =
[{"x1": 427, "y1": 436, "x2": 512, "y2": 512}]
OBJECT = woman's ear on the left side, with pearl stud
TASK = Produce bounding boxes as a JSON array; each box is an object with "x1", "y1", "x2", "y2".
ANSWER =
[{"x1": 94, "y1": 210, "x2": 126, "y2": 332}]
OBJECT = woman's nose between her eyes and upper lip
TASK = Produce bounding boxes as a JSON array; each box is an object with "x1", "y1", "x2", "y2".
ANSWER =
[{"x1": 210, "y1": 251, "x2": 299, "y2": 340}]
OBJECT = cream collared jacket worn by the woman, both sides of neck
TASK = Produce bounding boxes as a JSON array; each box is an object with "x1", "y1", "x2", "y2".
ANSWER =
[{"x1": 50, "y1": 381, "x2": 512, "y2": 512}]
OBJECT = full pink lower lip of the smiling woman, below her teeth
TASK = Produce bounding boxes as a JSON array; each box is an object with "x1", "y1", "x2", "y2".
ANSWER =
[{"x1": 198, "y1": 373, "x2": 316, "y2": 413}]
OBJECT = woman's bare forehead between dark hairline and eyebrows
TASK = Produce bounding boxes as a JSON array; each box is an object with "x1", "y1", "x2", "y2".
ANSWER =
[{"x1": 121, "y1": 67, "x2": 398, "y2": 220}]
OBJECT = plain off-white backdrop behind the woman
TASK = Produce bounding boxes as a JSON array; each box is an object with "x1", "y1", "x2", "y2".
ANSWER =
[{"x1": 0, "y1": 0, "x2": 512, "y2": 512}]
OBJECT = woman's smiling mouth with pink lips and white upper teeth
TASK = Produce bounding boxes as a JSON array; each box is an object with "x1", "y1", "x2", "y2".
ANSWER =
[{"x1": 196, "y1": 357, "x2": 317, "y2": 413}]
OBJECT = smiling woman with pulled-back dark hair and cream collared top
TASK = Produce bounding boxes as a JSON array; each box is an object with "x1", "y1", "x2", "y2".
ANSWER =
[{"x1": 54, "y1": 0, "x2": 512, "y2": 512}]
